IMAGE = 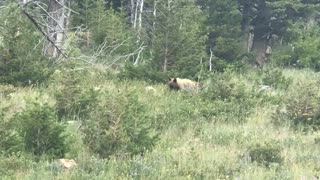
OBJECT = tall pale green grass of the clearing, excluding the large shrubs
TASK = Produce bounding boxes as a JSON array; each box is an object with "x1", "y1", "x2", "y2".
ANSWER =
[{"x1": 0, "y1": 67, "x2": 320, "y2": 179}]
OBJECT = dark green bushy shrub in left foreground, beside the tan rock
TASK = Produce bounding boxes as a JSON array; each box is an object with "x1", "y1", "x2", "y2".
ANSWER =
[{"x1": 12, "y1": 102, "x2": 68, "y2": 157}]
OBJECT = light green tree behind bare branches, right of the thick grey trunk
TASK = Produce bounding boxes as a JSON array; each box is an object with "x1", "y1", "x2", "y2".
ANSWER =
[{"x1": 84, "y1": 0, "x2": 139, "y2": 66}]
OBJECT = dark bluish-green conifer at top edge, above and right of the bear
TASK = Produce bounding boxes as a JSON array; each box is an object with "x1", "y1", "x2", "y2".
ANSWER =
[{"x1": 200, "y1": 0, "x2": 241, "y2": 63}]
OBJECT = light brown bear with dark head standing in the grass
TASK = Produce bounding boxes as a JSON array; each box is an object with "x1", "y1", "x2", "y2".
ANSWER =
[{"x1": 168, "y1": 78, "x2": 199, "y2": 91}]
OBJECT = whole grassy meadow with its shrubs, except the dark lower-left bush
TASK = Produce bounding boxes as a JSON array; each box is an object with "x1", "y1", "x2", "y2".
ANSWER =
[{"x1": 0, "y1": 67, "x2": 320, "y2": 180}]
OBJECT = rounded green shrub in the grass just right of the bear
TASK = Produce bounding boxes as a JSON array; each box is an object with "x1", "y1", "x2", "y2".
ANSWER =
[{"x1": 200, "y1": 71, "x2": 256, "y2": 122}]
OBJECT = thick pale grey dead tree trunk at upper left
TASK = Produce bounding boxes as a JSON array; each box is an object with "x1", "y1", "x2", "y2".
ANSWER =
[{"x1": 44, "y1": 0, "x2": 67, "y2": 58}]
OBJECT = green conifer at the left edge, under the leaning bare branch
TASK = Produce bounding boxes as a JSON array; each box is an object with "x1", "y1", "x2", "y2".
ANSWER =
[{"x1": 0, "y1": 3, "x2": 52, "y2": 85}]
